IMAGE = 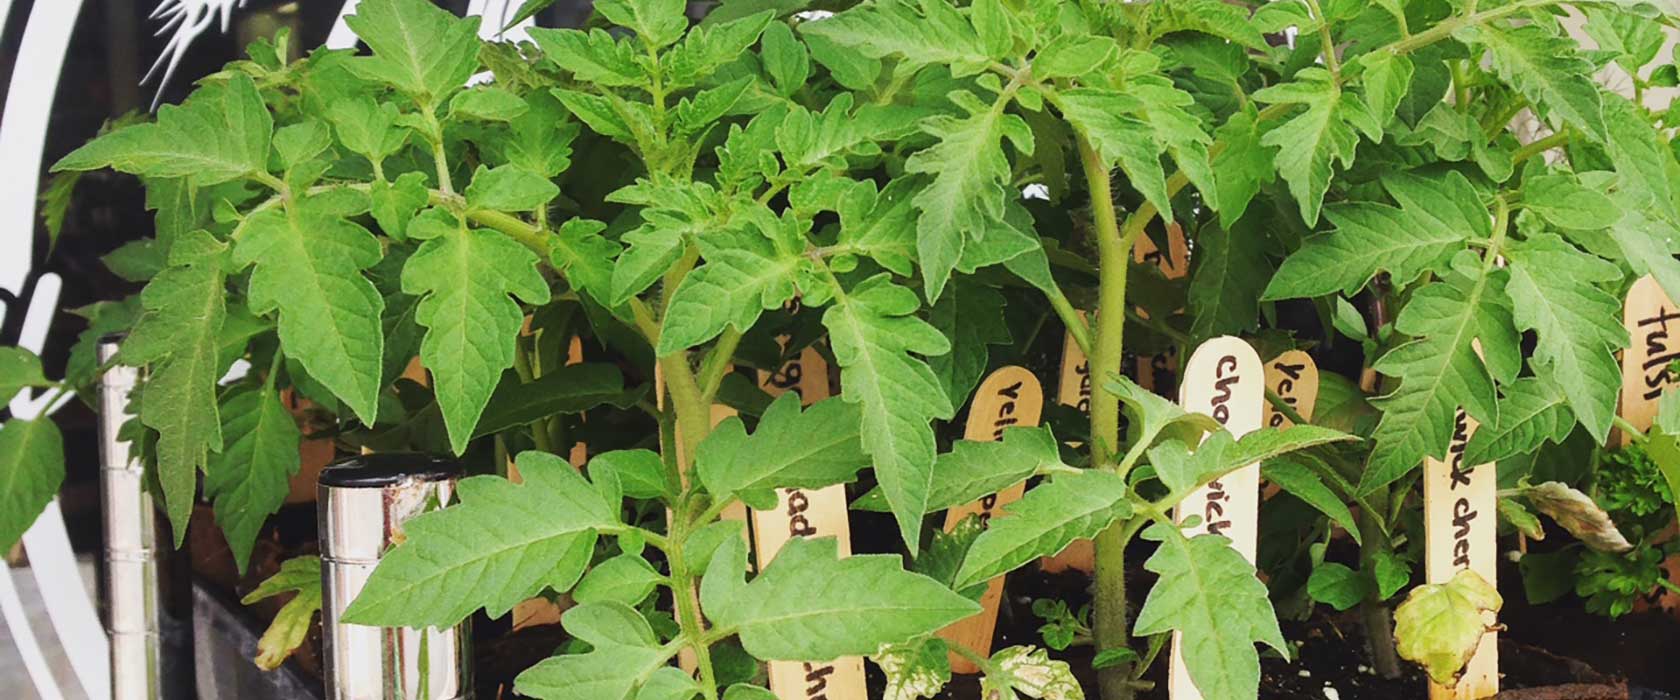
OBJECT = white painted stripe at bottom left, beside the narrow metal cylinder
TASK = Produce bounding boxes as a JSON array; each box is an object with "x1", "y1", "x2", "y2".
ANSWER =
[{"x1": 24, "y1": 499, "x2": 111, "y2": 700}]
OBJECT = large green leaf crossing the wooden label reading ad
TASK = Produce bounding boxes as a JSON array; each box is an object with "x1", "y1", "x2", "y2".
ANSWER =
[{"x1": 701, "y1": 537, "x2": 979, "y2": 661}]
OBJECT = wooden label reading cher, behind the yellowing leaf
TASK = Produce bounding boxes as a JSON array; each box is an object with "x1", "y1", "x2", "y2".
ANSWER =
[{"x1": 1423, "y1": 408, "x2": 1499, "y2": 700}]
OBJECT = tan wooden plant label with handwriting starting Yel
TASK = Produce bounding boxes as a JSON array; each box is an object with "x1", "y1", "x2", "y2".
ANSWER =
[{"x1": 939, "y1": 366, "x2": 1045, "y2": 673}]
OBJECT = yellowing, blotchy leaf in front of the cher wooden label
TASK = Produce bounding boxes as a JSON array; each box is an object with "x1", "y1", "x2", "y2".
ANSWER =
[{"x1": 1394, "y1": 569, "x2": 1504, "y2": 685}]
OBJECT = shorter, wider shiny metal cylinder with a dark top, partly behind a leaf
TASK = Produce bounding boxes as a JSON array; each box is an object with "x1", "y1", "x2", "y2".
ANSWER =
[{"x1": 318, "y1": 453, "x2": 472, "y2": 700}]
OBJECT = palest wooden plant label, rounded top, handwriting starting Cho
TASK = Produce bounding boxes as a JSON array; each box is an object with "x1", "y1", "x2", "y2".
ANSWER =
[{"x1": 1168, "y1": 336, "x2": 1265, "y2": 700}]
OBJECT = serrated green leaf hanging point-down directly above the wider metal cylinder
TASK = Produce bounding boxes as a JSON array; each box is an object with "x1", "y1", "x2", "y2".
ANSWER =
[{"x1": 403, "y1": 227, "x2": 549, "y2": 455}]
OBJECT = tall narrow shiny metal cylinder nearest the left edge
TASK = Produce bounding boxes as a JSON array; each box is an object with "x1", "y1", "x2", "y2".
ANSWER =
[{"x1": 97, "y1": 336, "x2": 193, "y2": 700}]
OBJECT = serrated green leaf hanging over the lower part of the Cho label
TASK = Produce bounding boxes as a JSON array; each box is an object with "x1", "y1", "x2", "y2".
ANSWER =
[{"x1": 1132, "y1": 524, "x2": 1289, "y2": 700}]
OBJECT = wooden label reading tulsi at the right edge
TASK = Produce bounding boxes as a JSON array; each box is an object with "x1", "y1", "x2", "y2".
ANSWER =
[{"x1": 1616, "y1": 275, "x2": 1680, "y2": 445}]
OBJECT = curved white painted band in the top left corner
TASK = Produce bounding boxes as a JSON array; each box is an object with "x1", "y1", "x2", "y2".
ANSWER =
[{"x1": 0, "y1": 0, "x2": 82, "y2": 294}]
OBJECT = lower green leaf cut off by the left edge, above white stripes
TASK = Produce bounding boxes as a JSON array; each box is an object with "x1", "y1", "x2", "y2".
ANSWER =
[{"x1": 0, "y1": 418, "x2": 64, "y2": 549}]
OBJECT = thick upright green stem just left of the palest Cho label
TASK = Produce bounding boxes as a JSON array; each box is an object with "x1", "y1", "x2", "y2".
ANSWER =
[{"x1": 1079, "y1": 138, "x2": 1142, "y2": 700}]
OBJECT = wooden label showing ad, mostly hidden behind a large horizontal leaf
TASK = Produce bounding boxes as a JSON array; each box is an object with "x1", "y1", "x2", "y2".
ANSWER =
[{"x1": 753, "y1": 345, "x2": 869, "y2": 700}]
